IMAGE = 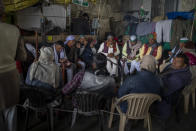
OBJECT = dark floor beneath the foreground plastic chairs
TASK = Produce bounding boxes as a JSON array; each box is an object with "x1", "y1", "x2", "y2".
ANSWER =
[{"x1": 19, "y1": 100, "x2": 196, "y2": 131}]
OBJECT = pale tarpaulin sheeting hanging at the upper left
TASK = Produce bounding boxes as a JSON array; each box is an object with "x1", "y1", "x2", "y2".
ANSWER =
[{"x1": 16, "y1": 5, "x2": 66, "y2": 30}]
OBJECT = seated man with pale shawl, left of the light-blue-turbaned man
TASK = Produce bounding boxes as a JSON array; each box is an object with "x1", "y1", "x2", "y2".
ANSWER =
[{"x1": 53, "y1": 41, "x2": 73, "y2": 82}]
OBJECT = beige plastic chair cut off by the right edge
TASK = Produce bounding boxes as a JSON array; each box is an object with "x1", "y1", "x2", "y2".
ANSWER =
[{"x1": 182, "y1": 66, "x2": 196, "y2": 114}]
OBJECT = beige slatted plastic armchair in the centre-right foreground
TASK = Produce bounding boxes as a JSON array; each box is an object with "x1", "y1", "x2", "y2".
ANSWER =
[{"x1": 108, "y1": 94, "x2": 161, "y2": 131}]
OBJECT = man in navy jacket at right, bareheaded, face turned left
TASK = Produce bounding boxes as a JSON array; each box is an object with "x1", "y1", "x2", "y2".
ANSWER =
[{"x1": 160, "y1": 54, "x2": 191, "y2": 96}]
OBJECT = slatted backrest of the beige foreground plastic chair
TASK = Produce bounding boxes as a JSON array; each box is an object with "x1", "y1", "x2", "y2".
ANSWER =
[{"x1": 116, "y1": 94, "x2": 161, "y2": 119}]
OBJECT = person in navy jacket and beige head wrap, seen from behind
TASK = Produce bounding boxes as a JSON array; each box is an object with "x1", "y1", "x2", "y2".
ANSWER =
[{"x1": 118, "y1": 55, "x2": 161, "y2": 112}]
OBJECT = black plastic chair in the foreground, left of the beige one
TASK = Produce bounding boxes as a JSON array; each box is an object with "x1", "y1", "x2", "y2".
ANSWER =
[{"x1": 71, "y1": 90, "x2": 103, "y2": 131}]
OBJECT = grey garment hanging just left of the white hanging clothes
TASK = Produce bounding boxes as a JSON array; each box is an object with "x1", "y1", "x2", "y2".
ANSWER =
[{"x1": 136, "y1": 22, "x2": 156, "y2": 36}]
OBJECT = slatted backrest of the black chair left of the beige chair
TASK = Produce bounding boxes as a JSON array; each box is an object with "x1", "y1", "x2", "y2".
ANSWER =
[{"x1": 73, "y1": 90, "x2": 103, "y2": 114}]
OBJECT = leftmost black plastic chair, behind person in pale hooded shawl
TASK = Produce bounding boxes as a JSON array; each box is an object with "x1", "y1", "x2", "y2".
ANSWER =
[{"x1": 20, "y1": 87, "x2": 60, "y2": 131}]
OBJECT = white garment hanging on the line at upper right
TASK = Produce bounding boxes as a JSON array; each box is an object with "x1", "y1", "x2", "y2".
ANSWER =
[{"x1": 155, "y1": 20, "x2": 172, "y2": 43}]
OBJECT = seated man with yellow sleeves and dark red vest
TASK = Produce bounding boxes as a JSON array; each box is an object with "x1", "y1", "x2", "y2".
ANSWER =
[{"x1": 140, "y1": 34, "x2": 162, "y2": 63}]
